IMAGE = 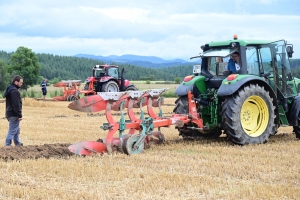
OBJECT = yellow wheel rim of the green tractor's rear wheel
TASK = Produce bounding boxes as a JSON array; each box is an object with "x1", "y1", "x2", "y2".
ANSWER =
[{"x1": 240, "y1": 96, "x2": 269, "y2": 137}]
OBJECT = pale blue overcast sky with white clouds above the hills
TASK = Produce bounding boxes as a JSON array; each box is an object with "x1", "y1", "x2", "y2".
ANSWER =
[{"x1": 0, "y1": 0, "x2": 300, "y2": 60}]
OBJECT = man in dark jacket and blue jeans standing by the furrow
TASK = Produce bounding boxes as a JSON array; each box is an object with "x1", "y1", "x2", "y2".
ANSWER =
[{"x1": 4, "y1": 75, "x2": 23, "y2": 146}]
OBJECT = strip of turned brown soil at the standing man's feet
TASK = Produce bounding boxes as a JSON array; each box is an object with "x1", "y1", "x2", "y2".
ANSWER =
[{"x1": 0, "y1": 143, "x2": 74, "y2": 160}]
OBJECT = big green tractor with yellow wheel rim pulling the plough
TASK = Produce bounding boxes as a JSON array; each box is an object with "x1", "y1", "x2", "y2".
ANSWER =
[{"x1": 174, "y1": 36, "x2": 300, "y2": 145}]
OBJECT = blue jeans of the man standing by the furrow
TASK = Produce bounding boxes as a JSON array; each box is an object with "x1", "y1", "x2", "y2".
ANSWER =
[{"x1": 5, "y1": 117, "x2": 22, "y2": 146}]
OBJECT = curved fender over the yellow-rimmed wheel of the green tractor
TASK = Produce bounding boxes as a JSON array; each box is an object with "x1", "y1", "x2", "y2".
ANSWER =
[{"x1": 217, "y1": 76, "x2": 280, "y2": 124}]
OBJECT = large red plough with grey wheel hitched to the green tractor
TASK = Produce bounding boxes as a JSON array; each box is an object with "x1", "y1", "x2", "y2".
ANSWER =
[{"x1": 69, "y1": 89, "x2": 203, "y2": 156}]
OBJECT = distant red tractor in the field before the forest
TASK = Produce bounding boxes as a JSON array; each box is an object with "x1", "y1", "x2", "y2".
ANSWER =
[{"x1": 80, "y1": 64, "x2": 138, "y2": 95}]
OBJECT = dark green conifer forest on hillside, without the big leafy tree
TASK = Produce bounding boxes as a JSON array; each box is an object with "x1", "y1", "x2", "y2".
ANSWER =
[{"x1": 0, "y1": 51, "x2": 300, "y2": 81}]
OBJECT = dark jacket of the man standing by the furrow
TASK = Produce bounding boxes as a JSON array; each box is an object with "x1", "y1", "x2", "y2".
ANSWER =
[{"x1": 4, "y1": 84, "x2": 22, "y2": 119}]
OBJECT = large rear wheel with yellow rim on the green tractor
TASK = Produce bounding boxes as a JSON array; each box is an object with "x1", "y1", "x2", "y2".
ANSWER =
[{"x1": 221, "y1": 84, "x2": 276, "y2": 145}]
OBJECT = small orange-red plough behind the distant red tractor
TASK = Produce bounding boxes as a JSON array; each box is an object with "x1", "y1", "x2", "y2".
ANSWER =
[{"x1": 53, "y1": 80, "x2": 81, "y2": 101}]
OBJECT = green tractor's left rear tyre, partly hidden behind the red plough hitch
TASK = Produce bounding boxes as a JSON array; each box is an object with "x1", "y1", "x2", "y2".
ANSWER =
[{"x1": 173, "y1": 96, "x2": 222, "y2": 139}]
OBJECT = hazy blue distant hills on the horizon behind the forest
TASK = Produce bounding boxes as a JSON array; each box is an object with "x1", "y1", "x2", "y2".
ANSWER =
[{"x1": 75, "y1": 54, "x2": 192, "y2": 68}]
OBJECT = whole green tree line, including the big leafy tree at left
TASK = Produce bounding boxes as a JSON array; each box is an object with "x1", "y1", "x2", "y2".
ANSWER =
[{"x1": 0, "y1": 47, "x2": 300, "y2": 91}]
